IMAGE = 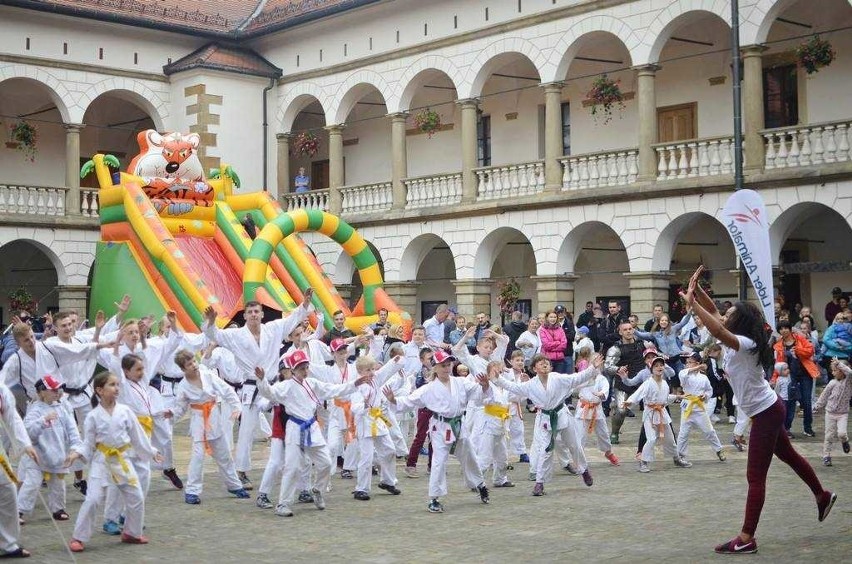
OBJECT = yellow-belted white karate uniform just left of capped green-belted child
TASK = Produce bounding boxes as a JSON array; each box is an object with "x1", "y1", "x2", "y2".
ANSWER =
[{"x1": 352, "y1": 359, "x2": 404, "y2": 493}]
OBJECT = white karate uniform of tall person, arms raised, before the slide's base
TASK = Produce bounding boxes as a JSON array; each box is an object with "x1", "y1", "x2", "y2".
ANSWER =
[{"x1": 204, "y1": 305, "x2": 311, "y2": 472}]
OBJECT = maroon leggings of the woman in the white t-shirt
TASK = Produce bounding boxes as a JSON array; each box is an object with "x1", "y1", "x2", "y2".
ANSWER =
[{"x1": 743, "y1": 399, "x2": 823, "y2": 535}]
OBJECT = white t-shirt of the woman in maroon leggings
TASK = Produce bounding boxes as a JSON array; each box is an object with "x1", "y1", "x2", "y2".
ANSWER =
[{"x1": 725, "y1": 335, "x2": 778, "y2": 417}]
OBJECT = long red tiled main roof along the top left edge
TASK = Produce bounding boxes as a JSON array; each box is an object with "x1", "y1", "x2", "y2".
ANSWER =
[{"x1": 2, "y1": 0, "x2": 378, "y2": 38}]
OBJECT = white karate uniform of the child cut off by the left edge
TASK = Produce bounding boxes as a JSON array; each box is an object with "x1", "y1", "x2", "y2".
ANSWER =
[{"x1": 0, "y1": 384, "x2": 32, "y2": 552}]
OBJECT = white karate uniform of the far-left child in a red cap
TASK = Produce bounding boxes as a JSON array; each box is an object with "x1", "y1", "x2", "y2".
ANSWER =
[{"x1": 18, "y1": 400, "x2": 81, "y2": 514}]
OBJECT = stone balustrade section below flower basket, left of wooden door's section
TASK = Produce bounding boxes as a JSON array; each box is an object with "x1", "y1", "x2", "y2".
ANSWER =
[{"x1": 559, "y1": 149, "x2": 639, "y2": 190}]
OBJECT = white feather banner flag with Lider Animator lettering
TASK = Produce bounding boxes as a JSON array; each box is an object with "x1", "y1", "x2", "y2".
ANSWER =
[{"x1": 722, "y1": 190, "x2": 775, "y2": 329}]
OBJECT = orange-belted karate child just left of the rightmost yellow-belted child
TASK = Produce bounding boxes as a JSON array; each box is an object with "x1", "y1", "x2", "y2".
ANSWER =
[{"x1": 621, "y1": 356, "x2": 692, "y2": 473}]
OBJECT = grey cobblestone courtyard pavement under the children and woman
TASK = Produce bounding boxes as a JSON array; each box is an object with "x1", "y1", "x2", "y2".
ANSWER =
[{"x1": 15, "y1": 409, "x2": 852, "y2": 563}]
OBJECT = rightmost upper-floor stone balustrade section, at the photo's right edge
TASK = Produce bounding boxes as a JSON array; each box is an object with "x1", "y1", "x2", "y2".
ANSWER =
[{"x1": 761, "y1": 120, "x2": 852, "y2": 170}]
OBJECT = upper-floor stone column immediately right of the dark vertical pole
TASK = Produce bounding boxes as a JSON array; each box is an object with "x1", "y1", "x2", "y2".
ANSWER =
[{"x1": 742, "y1": 45, "x2": 767, "y2": 172}]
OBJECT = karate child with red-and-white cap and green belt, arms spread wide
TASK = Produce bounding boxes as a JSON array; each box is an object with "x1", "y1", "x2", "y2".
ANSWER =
[{"x1": 383, "y1": 349, "x2": 492, "y2": 513}]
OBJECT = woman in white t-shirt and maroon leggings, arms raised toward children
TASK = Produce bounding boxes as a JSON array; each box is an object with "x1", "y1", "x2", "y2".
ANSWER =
[{"x1": 683, "y1": 266, "x2": 837, "y2": 554}]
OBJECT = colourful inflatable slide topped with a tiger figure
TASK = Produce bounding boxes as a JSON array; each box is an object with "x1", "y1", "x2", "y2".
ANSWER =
[{"x1": 81, "y1": 130, "x2": 411, "y2": 332}]
